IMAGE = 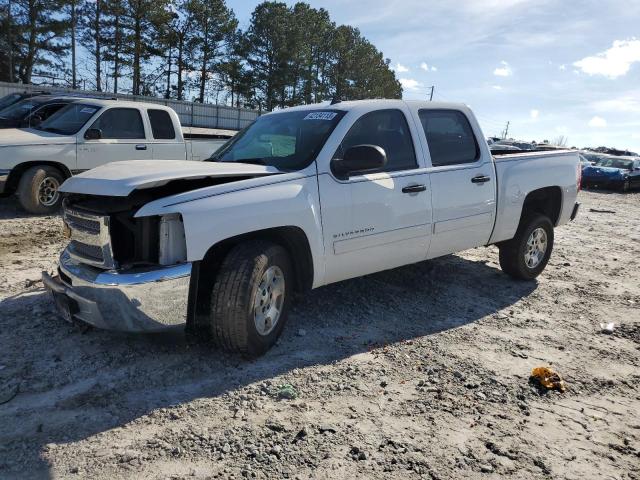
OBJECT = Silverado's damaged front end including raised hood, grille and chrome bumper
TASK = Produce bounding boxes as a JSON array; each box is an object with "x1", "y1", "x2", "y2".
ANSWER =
[{"x1": 43, "y1": 160, "x2": 279, "y2": 332}]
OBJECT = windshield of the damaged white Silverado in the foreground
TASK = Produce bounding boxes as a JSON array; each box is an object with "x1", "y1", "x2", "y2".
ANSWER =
[{"x1": 209, "y1": 110, "x2": 345, "y2": 171}]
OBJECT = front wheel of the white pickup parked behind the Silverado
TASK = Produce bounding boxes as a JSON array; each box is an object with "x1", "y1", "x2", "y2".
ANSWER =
[{"x1": 17, "y1": 165, "x2": 65, "y2": 214}]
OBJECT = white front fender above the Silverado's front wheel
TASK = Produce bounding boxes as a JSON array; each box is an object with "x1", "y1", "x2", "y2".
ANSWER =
[{"x1": 136, "y1": 175, "x2": 324, "y2": 286}]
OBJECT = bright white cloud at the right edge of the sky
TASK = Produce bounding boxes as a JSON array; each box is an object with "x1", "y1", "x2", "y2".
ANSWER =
[{"x1": 573, "y1": 39, "x2": 640, "y2": 78}]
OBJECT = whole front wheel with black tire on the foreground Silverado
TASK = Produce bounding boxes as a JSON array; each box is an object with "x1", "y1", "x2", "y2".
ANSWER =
[{"x1": 209, "y1": 240, "x2": 293, "y2": 357}]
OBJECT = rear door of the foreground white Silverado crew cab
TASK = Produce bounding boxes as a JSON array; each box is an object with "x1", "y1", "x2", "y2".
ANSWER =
[{"x1": 414, "y1": 107, "x2": 496, "y2": 258}]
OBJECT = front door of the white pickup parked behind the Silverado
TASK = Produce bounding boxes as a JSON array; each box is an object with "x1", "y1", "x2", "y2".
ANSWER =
[{"x1": 78, "y1": 107, "x2": 153, "y2": 170}]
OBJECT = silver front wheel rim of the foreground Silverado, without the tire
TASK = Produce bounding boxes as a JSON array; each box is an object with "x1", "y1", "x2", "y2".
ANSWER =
[{"x1": 253, "y1": 265, "x2": 285, "y2": 336}]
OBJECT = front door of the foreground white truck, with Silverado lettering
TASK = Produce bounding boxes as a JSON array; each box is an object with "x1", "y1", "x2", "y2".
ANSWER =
[{"x1": 318, "y1": 109, "x2": 431, "y2": 283}]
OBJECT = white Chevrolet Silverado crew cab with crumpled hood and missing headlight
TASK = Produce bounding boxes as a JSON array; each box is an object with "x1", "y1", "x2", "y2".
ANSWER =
[{"x1": 43, "y1": 100, "x2": 580, "y2": 356}]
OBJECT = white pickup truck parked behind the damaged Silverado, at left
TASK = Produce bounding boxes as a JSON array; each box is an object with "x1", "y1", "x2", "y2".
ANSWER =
[{"x1": 0, "y1": 98, "x2": 229, "y2": 213}]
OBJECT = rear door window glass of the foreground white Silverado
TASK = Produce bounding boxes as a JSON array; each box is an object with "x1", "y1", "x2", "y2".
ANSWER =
[{"x1": 418, "y1": 109, "x2": 480, "y2": 167}]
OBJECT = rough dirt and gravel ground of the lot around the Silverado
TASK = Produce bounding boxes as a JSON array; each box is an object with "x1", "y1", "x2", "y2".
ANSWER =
[{"x1": 0, "y1": 192, "x2": 640, "y2": 480}]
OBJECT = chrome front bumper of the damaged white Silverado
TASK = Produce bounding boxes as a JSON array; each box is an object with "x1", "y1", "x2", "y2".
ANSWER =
[{"x1": 42, "y1": 251, "x2": 191, "y2": 332}]
